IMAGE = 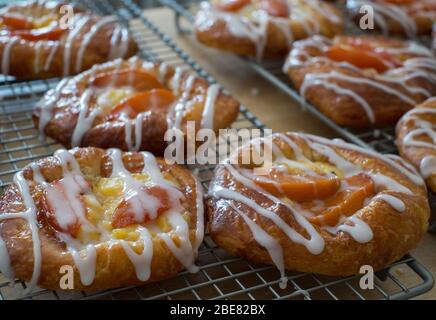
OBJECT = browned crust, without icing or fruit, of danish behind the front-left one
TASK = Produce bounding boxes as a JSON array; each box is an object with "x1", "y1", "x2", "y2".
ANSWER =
[{"x1": 33, "y1": 58, "x2": 239, "y2": 155}]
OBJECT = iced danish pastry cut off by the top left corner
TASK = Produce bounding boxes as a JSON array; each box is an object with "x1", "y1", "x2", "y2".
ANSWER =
[{"x1": 0, "y1": 1, "x2": 137, "y2": 80}]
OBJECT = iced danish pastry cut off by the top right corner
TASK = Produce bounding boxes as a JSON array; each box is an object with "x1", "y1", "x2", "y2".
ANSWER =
[{"x1": 347, "y1": 0, "x2": 436, "y2": 38}]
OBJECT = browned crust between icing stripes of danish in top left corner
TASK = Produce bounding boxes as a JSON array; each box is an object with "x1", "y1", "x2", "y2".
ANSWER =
[{"x1": 0, "y1": 1, "x2": 138, "y2": 80}]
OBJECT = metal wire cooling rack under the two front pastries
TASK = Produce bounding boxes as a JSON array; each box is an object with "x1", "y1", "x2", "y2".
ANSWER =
[{"x1": 0, "y1": 0, "x2": 433, "y2": 300}]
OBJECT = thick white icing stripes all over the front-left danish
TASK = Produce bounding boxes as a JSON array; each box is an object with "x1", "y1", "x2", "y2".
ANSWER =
[{"x1": 0, "y1": 149, "x2": 204, "y2": 290}]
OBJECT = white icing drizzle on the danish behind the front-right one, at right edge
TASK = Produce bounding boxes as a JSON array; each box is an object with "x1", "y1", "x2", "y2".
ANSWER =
[{"x1": 283, "y1": 36, "x2": 436, "y2": 123}]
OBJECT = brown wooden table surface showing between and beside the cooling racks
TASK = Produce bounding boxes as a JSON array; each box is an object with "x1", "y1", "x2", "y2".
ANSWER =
[{"x1": 146, "y1": 8, "x2": 436, "y2": 299}]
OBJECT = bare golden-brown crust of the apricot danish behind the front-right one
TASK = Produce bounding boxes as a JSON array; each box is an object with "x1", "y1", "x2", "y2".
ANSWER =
[{"x1": 284, "y1": 36, "x2": 436, "y2": 129}]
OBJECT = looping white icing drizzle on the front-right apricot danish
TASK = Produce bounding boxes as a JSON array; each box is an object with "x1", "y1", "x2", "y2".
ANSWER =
[{"x1": 209, "y1": 134, "x2": 423, "y2": 280}]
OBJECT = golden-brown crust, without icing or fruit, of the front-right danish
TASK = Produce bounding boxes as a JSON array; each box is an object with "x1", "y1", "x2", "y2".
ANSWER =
[{"x1": 207, "y1": 133, "x2": 430, "y2": 276}]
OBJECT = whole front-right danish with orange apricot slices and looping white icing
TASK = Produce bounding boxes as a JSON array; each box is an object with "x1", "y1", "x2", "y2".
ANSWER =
[{"x1": 207, "y1": 133, "x2": 430, "y2": 284}]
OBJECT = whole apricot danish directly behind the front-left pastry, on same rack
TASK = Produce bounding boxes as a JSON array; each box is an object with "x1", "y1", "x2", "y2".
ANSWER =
[{"x1": 33, "y1": 57, "x2": 239, "y2": 154}]
